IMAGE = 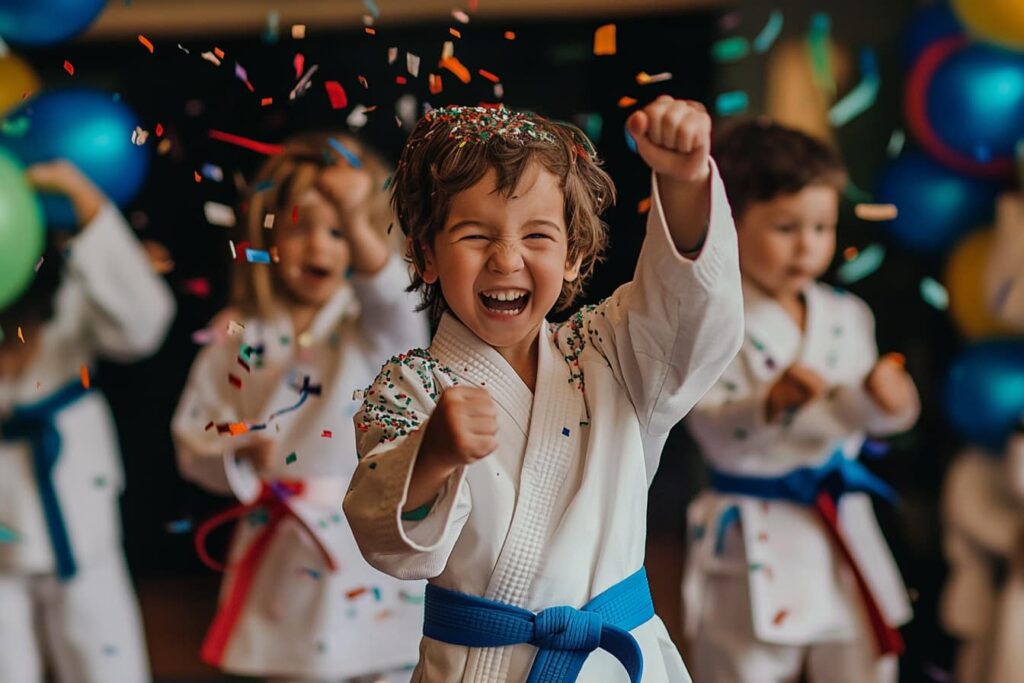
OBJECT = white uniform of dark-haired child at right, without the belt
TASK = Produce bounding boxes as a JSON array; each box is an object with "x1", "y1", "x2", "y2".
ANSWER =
[{"x1": 684, "y1": 281, "x2": 920, "y2": 681}]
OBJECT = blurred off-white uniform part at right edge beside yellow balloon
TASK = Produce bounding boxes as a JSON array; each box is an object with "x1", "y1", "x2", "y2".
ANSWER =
[{"x1": 984, "y1": 194, "x2": 1024, "y2": 330}]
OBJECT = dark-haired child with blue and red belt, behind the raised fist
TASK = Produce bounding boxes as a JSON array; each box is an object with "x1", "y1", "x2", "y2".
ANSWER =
[{"x1": 684, "y1": 121, "x2": 920, "y2": 683}]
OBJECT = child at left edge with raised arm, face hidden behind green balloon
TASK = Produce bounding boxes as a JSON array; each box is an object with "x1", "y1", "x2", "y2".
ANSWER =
[{"x1": 0, "y1": 161, "x2": 174, "y2": 683}]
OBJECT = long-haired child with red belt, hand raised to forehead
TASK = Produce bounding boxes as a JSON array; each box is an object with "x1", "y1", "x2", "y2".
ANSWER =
[{"x1": 172, "y1": 133, "x2": 428, "y2": 681}]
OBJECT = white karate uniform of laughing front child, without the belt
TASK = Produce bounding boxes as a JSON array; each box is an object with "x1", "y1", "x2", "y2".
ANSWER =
[{"x1": 345, "y1": 171, "x2": 742, "y2": 683}]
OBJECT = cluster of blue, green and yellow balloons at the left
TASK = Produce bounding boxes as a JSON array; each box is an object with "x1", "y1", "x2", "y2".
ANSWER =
[{"x1": 0, "y1": 0, "x2": 150, "y2": 310}]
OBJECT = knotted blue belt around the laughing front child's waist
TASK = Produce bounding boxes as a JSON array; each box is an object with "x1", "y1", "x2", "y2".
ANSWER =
[{"x1": 423, "y1": 568, "x2": 654, "y2": 683}]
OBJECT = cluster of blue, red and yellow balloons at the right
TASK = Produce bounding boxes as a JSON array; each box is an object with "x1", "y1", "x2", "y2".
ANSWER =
[{"x1": 892, "y1": 0, "x2": 1024, "y2": 453}]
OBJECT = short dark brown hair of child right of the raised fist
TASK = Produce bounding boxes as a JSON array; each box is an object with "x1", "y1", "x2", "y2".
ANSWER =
[{"x1": 712, "y1": 118, "x2": 847, "y2": 221}]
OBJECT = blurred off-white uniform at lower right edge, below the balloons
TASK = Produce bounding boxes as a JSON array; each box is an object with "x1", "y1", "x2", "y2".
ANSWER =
[{"x1": 939, "y1": 435, "x2": 1024, "y2": 683}]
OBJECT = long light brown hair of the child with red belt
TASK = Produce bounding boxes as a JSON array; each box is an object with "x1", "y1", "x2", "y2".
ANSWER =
[{"x1": 230, "y1": 131, "x2": 399, "y2": 316}]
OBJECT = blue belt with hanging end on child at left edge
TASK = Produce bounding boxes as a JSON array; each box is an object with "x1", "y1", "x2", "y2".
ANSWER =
[{"x1": 0, "y1": 382, "x2": 87, "y2": 579}]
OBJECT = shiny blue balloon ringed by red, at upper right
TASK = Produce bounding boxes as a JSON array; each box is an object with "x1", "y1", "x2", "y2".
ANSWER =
[{"x1": 926, "y1": 43, "x2": 1024, "y2": 163}]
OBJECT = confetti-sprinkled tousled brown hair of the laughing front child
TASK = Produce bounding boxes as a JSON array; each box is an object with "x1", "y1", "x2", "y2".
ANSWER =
[{"x1": 391, "y1": 106, "x2": 615, "y2": 322}]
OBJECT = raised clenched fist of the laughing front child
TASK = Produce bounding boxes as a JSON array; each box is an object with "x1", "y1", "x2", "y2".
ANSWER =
[{"x1": 626, "y1": 95, "x2": 711, "y2": 184}]
